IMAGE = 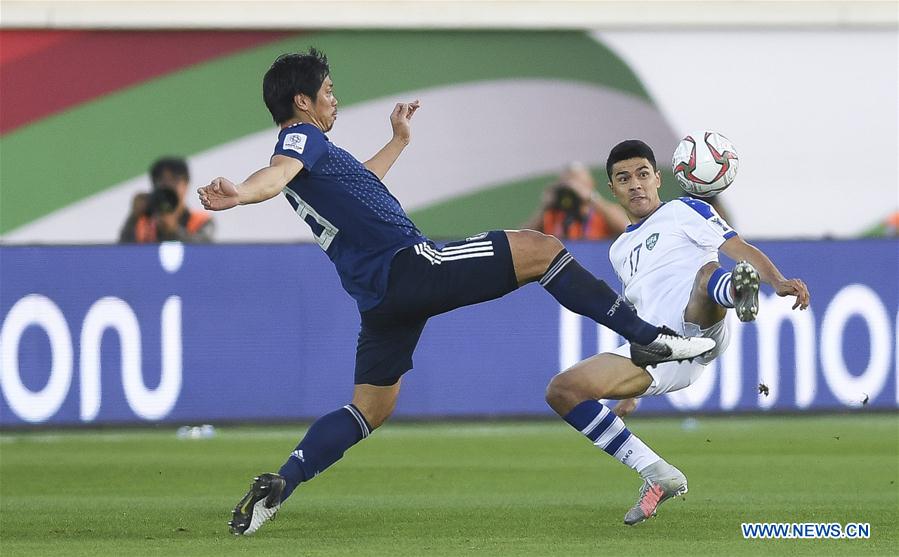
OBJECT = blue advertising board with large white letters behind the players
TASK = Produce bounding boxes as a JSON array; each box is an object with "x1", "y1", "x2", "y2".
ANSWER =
[{"x1": 0, "y1": 240, "x2": 899, "y2": 427}]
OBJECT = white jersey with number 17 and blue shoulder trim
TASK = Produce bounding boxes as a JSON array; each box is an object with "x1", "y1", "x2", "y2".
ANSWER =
[{"x1": 609, "y1": 197, "x2": 737, "y2": 333}]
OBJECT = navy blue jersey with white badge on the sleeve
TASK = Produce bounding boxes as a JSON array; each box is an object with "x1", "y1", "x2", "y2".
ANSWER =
[{"x1": 274, "y1": 124, "x2": 427, "y2": 311}]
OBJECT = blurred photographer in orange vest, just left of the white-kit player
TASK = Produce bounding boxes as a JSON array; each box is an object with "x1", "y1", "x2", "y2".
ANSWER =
[{"x1": 524, "y1": 162, "x2": 628, "y2": 240}]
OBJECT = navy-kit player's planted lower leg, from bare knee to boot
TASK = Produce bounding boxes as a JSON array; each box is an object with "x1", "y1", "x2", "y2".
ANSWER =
[{"x1": 228, "y1": 381, "x2": 400, "y2": 535}]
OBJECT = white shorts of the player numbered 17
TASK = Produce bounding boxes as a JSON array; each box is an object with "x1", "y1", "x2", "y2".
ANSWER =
[{"x1": 611, "y1": 319, "x2": 730, "y2": 398}]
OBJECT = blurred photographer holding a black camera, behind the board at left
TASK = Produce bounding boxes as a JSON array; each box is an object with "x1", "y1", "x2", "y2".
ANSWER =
[{"x1": 119, "y1": 157, "x2": 215, "y2": 244}]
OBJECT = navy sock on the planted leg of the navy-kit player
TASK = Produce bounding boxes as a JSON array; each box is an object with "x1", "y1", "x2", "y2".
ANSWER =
[{"x1": 278, "y1": 404, "x2": 371, "y2": 501}]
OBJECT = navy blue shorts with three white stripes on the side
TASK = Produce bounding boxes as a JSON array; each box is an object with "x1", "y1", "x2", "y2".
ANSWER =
[{"x1": 355, "y1": 230, "x2": 518, "y2": 386}]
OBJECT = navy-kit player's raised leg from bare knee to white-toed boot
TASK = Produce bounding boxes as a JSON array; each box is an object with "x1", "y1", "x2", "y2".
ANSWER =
[{"x1": 506, "y1": 230, "x2": 715, "y2": 366}]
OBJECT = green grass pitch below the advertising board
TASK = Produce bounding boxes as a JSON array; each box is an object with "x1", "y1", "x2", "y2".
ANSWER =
[{"x1": 0, "y1": 414, "x2": 899, "y2": 557}]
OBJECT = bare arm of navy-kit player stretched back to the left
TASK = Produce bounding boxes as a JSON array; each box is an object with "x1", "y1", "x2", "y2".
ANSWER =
[{"x1": 197, "y1": 155, "x2": 303, "y2": 211}]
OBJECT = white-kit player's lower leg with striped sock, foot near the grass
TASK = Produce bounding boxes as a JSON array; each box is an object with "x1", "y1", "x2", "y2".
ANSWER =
[{"x1": 546, "y1": 353, "x2": 687, "y2": 524}]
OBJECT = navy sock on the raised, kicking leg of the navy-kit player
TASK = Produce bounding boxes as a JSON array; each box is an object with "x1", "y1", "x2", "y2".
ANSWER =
[{"x1": 540, "y1": 250, "x2": 659, "y2": 344}]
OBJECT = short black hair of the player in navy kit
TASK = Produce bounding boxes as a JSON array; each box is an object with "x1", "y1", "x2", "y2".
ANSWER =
[{"x1": 262, "y1": 48, "x2": 331, "y2": 124}]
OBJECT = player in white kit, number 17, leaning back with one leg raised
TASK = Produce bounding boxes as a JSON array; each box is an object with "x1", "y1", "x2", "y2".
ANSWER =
[{"x1": 546, "y1": 140, "x2": 809, "y2": 524}]
